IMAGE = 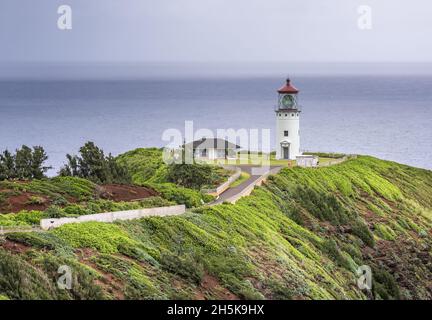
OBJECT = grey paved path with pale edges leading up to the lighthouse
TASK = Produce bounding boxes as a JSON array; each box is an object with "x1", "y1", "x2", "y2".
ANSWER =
[{"x1": 209, "y1": 165, "x2": 283, "y2": 205}]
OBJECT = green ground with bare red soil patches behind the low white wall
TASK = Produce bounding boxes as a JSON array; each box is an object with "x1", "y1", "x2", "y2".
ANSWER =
[{"x1": 0, "y1": 177, "x2": 174, "y2": 228}]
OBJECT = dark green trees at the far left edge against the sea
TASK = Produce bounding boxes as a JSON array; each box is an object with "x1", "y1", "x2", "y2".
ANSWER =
[{"x1": 0, "y1": 145, "x2": 51, "y2": 181}]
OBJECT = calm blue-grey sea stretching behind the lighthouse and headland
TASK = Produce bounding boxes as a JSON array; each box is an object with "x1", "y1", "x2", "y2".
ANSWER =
[{"x1": 0, "y1": 75, "x2": 432, "y2": 174}]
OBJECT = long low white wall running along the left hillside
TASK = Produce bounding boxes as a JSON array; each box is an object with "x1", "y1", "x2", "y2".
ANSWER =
[{"x1": 40, "y1": 204, "x2": 186, "y2": 230}]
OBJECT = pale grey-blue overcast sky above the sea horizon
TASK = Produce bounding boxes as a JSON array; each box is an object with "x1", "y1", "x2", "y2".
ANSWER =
[{"x1": 0, "y1": 0, "x2": 432, "y2": 77}]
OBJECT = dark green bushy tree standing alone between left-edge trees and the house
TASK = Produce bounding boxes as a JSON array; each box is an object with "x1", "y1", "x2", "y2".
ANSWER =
[{"x1": 59, "y1": 141, "x2": 131, "y2": 183}]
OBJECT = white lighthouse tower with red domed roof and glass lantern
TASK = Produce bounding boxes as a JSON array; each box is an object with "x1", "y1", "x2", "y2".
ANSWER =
[{"x1": 275, "y1": 79, "x2": 301, "y2": 160}]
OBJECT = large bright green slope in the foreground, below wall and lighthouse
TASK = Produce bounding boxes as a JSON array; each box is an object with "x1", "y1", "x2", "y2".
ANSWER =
[{"x1": 0, "y1": 157, "x2": 432, "y2": 299}]
